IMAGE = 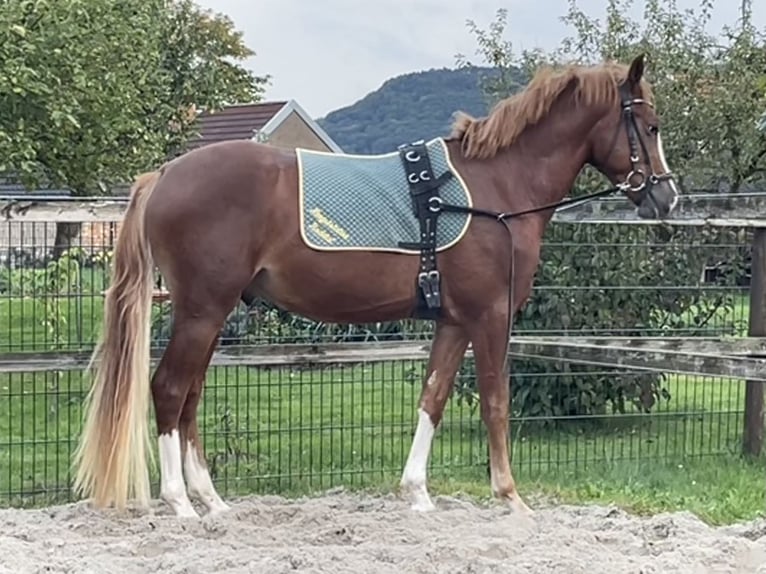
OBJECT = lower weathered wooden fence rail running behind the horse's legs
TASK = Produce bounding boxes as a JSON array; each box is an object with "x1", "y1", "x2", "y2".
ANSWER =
[{"x1": 0, "y1": 336, "x2": 766, "y2": 380}]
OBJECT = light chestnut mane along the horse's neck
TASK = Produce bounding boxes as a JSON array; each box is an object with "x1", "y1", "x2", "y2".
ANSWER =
[{"x1": 449, "y1": 62, "x2": 652, "y2": 158}]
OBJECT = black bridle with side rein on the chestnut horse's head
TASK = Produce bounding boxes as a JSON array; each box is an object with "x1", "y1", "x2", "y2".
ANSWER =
[{"x1": 428, "y1": 83, "x2": 673, "y2": 221}]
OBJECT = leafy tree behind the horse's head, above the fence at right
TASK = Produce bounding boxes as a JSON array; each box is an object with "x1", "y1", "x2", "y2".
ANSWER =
[{"x1": 461, "y1": 0, "x2": 766, "y2": 195}]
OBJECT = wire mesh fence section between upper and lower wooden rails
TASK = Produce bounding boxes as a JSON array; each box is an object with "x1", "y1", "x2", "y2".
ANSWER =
[{"x1": 0, "y1": 220, "x2": 751, "y2": 351}]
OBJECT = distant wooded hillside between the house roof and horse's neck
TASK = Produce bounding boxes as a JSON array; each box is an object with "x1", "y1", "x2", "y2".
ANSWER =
[{"x1": 317, "y1": 67, "x2": 524, "y2": 154}]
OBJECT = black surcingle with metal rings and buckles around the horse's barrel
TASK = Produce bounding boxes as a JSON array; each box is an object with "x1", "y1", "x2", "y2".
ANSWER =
[{"x1": 398, "y1": 140, "x2": 452, "y2": 319}]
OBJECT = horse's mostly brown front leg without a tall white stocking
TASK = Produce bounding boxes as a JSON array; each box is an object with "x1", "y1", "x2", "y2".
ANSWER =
[{"x1": 471, "y1": 305, "x2": 532, "y2": 514}]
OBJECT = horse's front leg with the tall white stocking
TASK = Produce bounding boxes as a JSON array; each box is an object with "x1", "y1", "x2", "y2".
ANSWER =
[{"x1": 400, "y1": 323, "x2": 468, "y2": 512}]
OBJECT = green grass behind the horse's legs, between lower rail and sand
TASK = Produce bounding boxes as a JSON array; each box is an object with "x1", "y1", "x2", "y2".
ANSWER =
[{"x1": 0, "y1": 362, "x2": 766, "y2": 523}]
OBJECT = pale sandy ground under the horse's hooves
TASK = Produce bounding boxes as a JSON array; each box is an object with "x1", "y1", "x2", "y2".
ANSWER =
[{"x1": 0, "y1": 492, "x2": 766, "y2": 574}]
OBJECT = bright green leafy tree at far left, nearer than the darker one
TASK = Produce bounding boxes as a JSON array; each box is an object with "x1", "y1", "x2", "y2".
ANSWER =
[{"x1": 0, "y1": 0, "x2": 167, "y2": 194}]
